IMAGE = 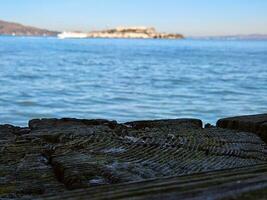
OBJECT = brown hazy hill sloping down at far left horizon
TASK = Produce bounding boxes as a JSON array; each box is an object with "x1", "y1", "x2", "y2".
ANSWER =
[{"x1": 0, "y1": 20, "x2": 58, "y2": 36}]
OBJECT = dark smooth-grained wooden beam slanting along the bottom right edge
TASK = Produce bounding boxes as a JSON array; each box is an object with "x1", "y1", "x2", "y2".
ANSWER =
[{"x1": 40, "y1": 165, "x2": 267, "y2": 200}]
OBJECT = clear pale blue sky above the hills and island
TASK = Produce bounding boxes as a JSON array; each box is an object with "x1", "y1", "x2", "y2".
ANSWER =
[{"x1": 0, "y1": 0, "x2": 267, "y2": 36}]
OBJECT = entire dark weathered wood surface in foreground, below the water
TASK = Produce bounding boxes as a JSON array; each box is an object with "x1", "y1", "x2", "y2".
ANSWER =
[{"x1": 0, "y1": 114, "x2": 267, "y2": 200}]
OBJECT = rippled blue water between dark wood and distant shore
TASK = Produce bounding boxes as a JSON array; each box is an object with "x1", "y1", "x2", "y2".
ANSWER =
[{"x1": 0, "y1": 37, "x2": 267, "y2": 126}]
